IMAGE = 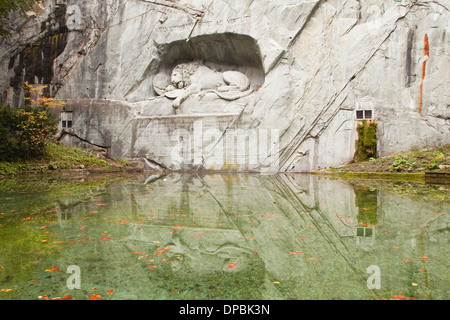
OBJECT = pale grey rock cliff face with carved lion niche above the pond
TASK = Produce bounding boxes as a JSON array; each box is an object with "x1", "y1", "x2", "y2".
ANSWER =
[{"x1": 0, "y1": 0, "x2": 450, "y2": 171}]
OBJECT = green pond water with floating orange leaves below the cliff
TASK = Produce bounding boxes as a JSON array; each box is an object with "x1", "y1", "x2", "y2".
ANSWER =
[{"x1": 0, "y1": 174, "x2": 450, "y2": 300}]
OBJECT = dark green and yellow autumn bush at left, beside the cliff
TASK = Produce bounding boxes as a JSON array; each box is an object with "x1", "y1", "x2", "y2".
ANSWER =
[{"x1": 0, "y1": 83, "x2": 64, "y2": 161}]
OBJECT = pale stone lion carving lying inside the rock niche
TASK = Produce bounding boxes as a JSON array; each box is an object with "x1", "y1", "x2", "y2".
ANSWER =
[{"x1": 153, "y1": 62, "x2": 253, "y2": 108}]
